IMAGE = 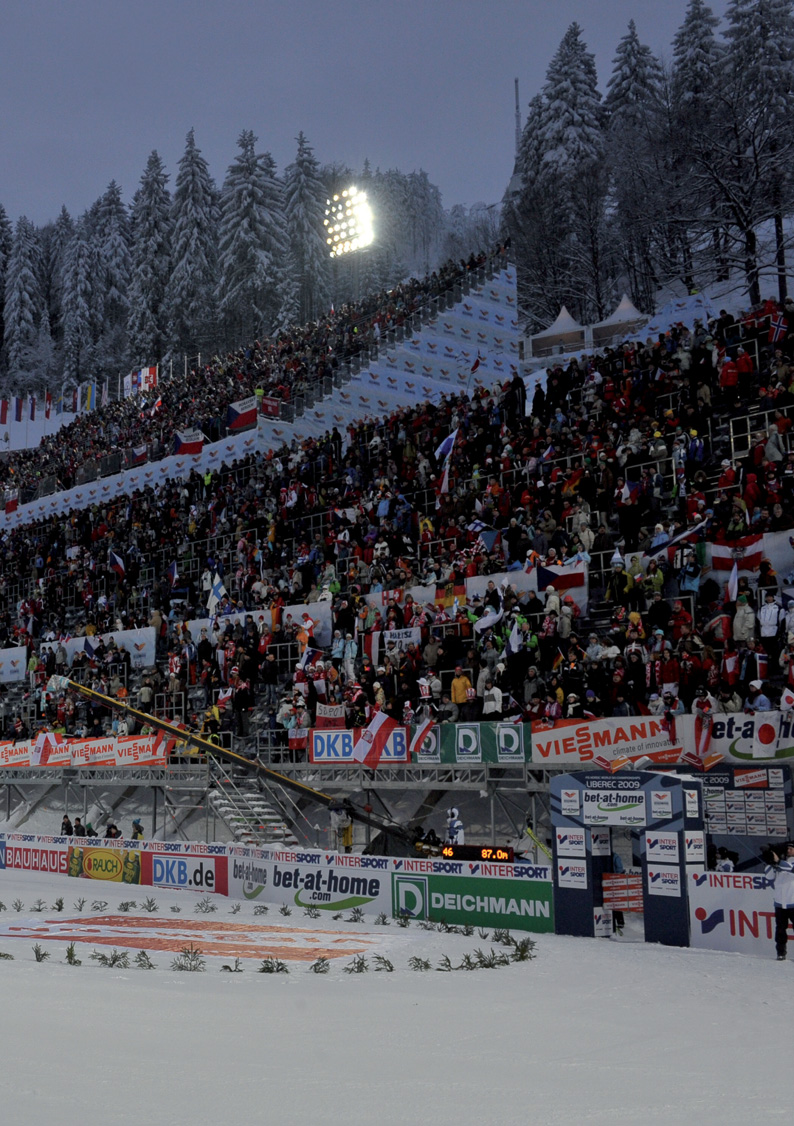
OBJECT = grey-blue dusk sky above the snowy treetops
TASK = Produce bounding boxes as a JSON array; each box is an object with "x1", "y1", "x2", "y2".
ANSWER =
[{"x1": 0, "y1": 0, "x2": 728, "y2": 223}]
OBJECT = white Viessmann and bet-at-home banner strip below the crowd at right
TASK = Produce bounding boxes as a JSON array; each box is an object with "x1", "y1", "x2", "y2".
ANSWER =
[{"x1": 532, "y1": 712, "x2": 794, "y2": 768}]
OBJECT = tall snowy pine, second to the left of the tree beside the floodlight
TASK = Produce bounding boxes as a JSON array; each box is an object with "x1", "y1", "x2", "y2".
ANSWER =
[{"x1": 167, "y1": 129, "x2": 218, "y2": 352}]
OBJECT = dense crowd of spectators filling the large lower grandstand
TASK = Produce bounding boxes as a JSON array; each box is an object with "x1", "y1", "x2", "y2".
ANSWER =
[{"x1": 0, "y1": 261, "x2": 794, "y2": 738}]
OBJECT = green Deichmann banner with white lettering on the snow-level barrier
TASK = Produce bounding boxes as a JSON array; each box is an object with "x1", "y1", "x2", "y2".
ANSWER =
[{"x1": 392, "y1": 865, "x2": 554, "y2": 932}]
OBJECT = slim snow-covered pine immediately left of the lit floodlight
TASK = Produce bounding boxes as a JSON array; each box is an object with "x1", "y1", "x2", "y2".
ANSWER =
[{"x1": 284, "y1": 132, "x2": 330, "y2": 322}]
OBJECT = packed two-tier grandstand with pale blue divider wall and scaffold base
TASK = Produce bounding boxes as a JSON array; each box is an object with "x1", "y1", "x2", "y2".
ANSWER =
[{"x1": 0, "y1": 248, "x2": 794, "y2": 845}]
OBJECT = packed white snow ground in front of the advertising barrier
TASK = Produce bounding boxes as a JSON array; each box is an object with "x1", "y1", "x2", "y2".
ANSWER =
[{"x1": 0, "y1": 872, "x2": 794, "y2": 1126}]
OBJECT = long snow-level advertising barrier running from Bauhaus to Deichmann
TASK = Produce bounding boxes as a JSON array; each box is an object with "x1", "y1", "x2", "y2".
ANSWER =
[{"x1": 0, "y1": 833, "x2": 554, "y2": 933}]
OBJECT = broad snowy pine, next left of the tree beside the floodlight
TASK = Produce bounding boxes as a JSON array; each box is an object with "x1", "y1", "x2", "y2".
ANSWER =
[{"x1": 217, "y1": 129, "x2": 286, "y2": 347}]
